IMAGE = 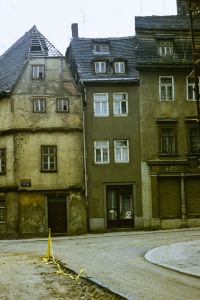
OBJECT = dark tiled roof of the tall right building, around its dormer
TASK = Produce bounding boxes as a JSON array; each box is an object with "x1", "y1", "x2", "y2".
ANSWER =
[{"x1": 135, "y1": 15, "x2": 200, "y2": 68}]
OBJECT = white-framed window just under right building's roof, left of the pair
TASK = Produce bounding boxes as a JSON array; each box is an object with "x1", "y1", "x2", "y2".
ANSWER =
[{"x1": 159, "y1": 76, "x2": 174, "y2": 101}]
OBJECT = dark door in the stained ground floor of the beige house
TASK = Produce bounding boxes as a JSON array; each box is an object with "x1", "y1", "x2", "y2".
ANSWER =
[{"x1": 47, "y1": 196, "x2": 67, "y2": 233}]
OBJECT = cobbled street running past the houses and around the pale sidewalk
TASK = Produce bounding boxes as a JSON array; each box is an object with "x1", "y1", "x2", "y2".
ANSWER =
[{"x1": 0, "y1": 229, "x2": 200, "y2": 300}]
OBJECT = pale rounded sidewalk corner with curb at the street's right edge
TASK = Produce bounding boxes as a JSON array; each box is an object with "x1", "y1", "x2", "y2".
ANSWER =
[{"x1": 145, "y1": 240, "x2": 200, "y2": 277}]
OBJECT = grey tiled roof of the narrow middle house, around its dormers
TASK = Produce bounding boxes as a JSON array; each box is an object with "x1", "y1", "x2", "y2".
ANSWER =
[{"x1": 66, "y1": 37, "x2": 139, "y2": 81}]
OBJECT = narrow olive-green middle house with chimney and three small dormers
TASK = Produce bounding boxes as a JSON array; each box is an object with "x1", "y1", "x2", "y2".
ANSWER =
[{"x1": 66, "y1": 29, "x2": 142, "y2": 231}]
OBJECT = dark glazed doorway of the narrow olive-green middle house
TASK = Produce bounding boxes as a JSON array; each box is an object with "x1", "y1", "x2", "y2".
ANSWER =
[{"x1": 106, "y1": 185, "x2": 134, "y2": 228}]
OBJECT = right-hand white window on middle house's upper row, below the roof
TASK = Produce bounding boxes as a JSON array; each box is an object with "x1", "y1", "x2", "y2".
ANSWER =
[{"x1": 113, "y1": 93, "x2": 128, "y2": 116}]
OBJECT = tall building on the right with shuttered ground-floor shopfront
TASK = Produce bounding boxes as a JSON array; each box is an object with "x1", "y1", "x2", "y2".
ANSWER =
[{"x1": 135, "y1": 7, "x2": 200, "y2": 229}]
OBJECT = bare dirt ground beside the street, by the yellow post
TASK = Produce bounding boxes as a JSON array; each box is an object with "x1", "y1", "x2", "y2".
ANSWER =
[{"x1": 0, "y1": 252, "x2": 124, "y2": 300}]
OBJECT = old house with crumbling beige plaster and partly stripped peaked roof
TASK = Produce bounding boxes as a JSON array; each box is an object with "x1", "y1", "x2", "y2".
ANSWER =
[{"x1": 0, "y1": 26, "x2": 86, "y2": 238}]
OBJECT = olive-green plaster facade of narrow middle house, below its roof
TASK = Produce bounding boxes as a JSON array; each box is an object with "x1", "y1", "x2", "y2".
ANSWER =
[{"x1": 84, "y1": 82, "x2": 142, "y2": 231}]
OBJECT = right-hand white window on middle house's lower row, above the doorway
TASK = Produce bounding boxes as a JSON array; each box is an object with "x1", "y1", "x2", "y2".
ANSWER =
[{"x1": 114, "y1": 140, "x2": 129, "y2": 163}]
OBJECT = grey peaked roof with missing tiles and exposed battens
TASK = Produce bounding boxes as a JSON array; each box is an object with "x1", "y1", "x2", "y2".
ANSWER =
[{"x1": 0, "y1": 26, "x2": 62, "y2": 95}]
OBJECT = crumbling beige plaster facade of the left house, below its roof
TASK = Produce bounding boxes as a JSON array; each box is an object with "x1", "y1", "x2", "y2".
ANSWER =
[{"x1": 0, "y1": 57, "x2": 87, "y2": 238}]
